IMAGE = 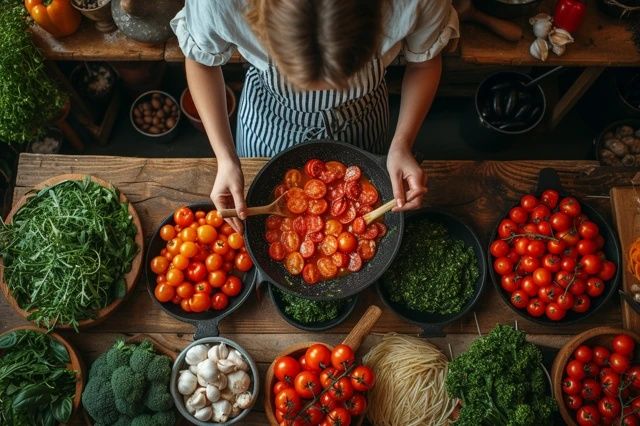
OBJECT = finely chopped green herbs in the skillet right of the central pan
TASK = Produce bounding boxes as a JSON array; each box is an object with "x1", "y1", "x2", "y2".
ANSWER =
[{"x1": 383, "y1": 220, "x2": 480, "y2": 315}]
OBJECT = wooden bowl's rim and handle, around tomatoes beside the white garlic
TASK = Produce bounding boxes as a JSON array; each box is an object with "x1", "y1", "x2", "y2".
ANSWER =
[{"x1": 263, "y1": 305, "x2": 382, "y2": 426}]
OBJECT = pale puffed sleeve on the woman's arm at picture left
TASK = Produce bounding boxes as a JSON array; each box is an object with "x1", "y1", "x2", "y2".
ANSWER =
[{"x1": 171, "y1": 0, "x2": 236, "y2": 66}]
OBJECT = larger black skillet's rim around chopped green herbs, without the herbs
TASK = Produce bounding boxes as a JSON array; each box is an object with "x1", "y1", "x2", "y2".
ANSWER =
[{"x1": 376, "y1": 208, "x2": 487, "y2": 337}]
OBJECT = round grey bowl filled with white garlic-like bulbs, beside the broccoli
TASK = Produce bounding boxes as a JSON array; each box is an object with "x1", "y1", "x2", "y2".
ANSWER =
[{"x1": 171, "y1": 337, "x2": 260, "y2": 426}]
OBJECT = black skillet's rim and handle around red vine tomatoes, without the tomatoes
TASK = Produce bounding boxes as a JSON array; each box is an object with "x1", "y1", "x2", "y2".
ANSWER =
[{"x1": 487, "y1": 168, "x2": 621, "y2": 327}]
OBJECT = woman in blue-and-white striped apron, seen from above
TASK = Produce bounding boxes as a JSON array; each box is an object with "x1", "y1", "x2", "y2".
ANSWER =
[{"x1": 171, "y1": 0, "x2": 458, "y2": 226}]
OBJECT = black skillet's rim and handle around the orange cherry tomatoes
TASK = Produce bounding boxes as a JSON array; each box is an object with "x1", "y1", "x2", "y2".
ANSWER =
[{"x1": 144, "y1": 203, "x2": 257, "y2": 340}]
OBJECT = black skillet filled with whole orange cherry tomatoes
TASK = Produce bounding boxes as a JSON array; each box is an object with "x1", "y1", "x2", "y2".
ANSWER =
[{"x1": 145, "y1": 203, "x2": 256, "y2": 339}]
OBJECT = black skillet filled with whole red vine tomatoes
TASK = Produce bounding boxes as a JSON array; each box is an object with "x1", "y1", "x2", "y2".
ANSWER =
[{"x1": 488, "y1": 169, "x2": 620, "y2": 326}]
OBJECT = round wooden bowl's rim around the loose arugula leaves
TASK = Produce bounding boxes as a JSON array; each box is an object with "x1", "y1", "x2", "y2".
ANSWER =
[{"x1": 0, "y1": 174, "x2": 144, "y2": 330}]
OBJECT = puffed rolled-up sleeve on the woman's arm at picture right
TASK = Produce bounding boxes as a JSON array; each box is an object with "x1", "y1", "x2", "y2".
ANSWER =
[{"x1": 403, "y1": 0, "x2": 460, "y2": 62}]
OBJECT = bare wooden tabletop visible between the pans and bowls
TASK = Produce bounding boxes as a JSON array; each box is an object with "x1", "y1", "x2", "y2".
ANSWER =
[{"x1": 0, "y1": 154, "x2": 637, "y2": 425}]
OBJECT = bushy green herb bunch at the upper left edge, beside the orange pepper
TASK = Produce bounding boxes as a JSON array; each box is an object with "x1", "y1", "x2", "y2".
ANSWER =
[{"x1": 0, "y1": 0, "x2": 67, "y2": 143}]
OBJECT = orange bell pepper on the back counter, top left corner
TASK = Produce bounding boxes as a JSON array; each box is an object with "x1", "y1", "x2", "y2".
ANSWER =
[{"x1": 24, "y1": 0, "x2": 82, "y2": 37}]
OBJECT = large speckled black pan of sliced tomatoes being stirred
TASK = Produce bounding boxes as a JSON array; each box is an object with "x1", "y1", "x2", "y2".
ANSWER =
[{"x1": 245, "y1": 141, "x2": 404, "y2": 300}]
